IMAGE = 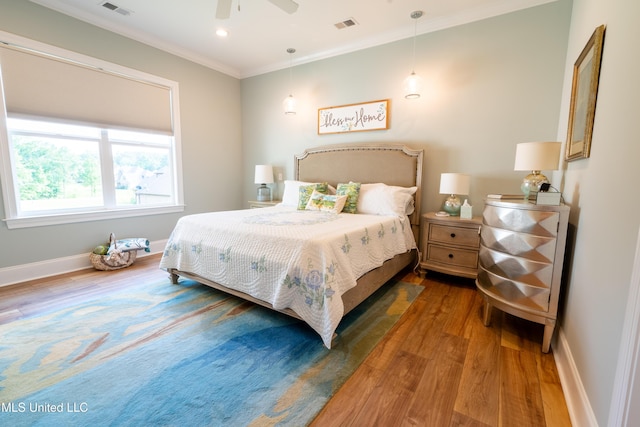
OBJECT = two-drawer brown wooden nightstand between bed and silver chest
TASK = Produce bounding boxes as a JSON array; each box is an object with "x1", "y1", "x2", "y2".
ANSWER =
[{"x1": 420, "y1": 212, "x2": 482, "y2": 279}]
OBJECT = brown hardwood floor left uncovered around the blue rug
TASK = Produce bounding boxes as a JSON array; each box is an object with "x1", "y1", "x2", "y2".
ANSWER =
[{"x1": 0, "y1": 255, "x2": 571, "y2": 427}]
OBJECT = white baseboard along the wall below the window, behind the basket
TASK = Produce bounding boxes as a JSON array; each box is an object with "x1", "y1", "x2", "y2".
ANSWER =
[{"x1": 0, "y1": 239, "x2": 167, "y2": 287}]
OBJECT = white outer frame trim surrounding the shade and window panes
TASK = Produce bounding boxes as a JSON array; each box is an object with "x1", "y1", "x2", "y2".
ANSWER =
[{"x1": 0, "y1": 31, "x2": 184, "y2": 229}]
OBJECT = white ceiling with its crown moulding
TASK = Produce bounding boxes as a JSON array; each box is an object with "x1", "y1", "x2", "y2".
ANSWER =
[{"x1": 31, "y1": 0, "x2": 555, "y2": 78}]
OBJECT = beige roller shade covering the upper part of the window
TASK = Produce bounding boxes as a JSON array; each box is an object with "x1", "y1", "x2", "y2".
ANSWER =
[{"x1": 0, "y1": 45, "x2": 174, "y2": 134}]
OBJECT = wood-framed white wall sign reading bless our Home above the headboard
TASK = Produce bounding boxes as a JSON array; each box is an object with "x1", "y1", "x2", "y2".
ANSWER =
[{"x1": 318, "y1": 99, "x2": 389, "y2": 135}]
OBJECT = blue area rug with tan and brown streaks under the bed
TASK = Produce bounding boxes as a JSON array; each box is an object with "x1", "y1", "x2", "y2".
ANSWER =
[{"x1": 0, "y1": 280, "x2": 423, "y2": 426}]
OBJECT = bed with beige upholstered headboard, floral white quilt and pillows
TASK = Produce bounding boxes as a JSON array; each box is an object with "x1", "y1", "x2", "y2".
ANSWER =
[{"x1": 160, "y1": 144, "x2": 423, "y2": 348}]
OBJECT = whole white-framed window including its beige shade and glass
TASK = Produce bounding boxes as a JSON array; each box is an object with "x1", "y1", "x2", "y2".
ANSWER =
[{"x1": 0, "y1": 32, "x2": 183, "y2": 228}]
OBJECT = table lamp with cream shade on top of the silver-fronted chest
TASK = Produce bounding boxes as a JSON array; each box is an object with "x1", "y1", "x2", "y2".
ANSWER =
[{"x1": 513, "y1": 142, "x2": 562, "y2": 200}]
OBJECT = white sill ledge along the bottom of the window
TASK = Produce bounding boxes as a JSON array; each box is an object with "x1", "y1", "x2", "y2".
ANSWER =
[{"x1": 4, "y1": 205, "x2": 184, "y2": 229}]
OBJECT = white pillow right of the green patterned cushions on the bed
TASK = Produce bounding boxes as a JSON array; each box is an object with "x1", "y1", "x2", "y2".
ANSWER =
[{"x1": 358, "y1": 183, "x2": 418, "y2": 216}]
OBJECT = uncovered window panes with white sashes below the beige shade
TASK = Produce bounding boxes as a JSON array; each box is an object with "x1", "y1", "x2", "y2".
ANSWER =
[{"x1": 7, "y1": 118, "x2": 175, "y2": 216}]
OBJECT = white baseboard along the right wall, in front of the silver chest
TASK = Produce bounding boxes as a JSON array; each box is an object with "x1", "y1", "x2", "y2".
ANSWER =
[{"x1": 553, "y1": 328, "x2": 598, "y2": 427}]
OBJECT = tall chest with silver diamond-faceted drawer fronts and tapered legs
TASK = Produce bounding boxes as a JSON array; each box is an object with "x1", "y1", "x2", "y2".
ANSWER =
[{"x1": 476, "y1": 199, "x2": 569, "y2": 353}]
